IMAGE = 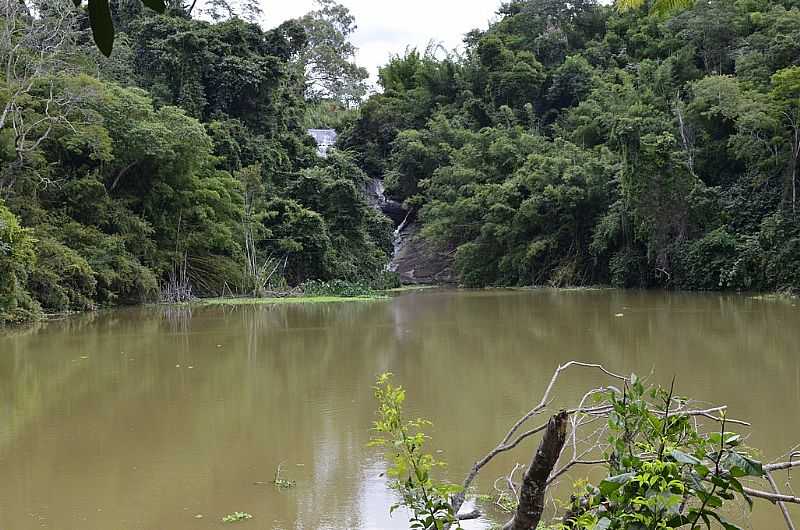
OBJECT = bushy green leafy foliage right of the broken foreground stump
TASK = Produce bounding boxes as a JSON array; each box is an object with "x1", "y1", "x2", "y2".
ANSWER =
[{"x1": 565, "y1": 376, "x2": 763, "y2": 530}]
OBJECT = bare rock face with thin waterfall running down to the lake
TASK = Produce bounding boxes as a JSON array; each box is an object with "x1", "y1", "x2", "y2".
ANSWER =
[{"x1": 365, "y1": 179, "x2": 454, "y2": 284}]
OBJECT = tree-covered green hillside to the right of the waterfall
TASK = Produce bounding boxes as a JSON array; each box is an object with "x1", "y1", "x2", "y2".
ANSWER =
[{"x1": 342, "y1": 0, "x2": 800, "y2": 290}]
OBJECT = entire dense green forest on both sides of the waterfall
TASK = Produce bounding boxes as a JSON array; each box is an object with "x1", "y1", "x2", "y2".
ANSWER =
[{"x1": 0, "y1": 0, "x2": 800, "y2": 321}]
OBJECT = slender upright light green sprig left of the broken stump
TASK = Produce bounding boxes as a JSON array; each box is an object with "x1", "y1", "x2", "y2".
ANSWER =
[{"x1": 370, "y1": 373, "x2": 461, "y2": 530}]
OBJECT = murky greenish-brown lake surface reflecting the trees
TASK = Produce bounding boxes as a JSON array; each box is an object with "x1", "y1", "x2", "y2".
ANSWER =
[{"x1": 0, "y1": 290, "x2": 800, "y2": 530}]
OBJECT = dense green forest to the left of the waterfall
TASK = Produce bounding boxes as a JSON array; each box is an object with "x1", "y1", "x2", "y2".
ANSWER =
[{"x1": 0, "y1": 0, "x2": 392, "y2": 321}]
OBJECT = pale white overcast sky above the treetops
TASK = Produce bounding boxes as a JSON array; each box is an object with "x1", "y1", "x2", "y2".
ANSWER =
[{"x1": 261, "y1": 0, "x2": 501, "y2": 83}]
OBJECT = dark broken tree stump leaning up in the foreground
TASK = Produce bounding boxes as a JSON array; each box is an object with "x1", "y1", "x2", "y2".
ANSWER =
[{"x1": 503, "y1": 410, "x2": 567, "y2": 530}]
